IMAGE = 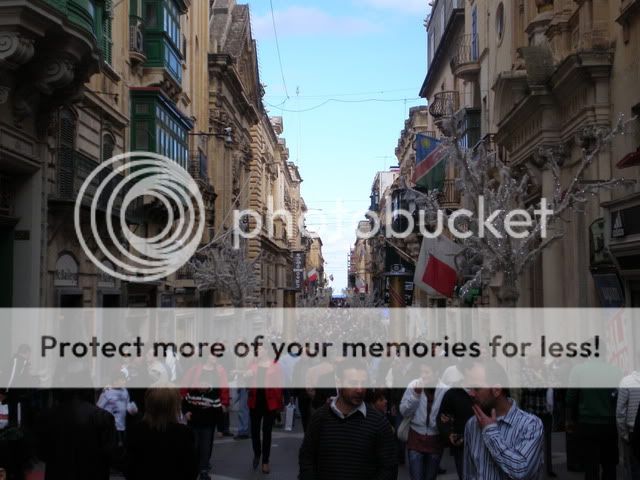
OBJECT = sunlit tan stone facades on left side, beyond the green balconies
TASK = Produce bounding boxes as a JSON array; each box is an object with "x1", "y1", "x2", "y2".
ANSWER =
[{"x1": 201, "y1": 0, "x2": 312, "y2": 306}]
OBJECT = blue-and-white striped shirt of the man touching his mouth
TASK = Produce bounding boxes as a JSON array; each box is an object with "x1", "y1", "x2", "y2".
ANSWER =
[{"x1": 464, "y1": 400, "x2": 543, "y2": 480}]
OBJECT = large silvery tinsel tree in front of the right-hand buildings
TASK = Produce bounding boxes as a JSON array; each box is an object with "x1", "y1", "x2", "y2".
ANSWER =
[{"x1": 405, "y1": 116, "x2": 635, "y2": 307}]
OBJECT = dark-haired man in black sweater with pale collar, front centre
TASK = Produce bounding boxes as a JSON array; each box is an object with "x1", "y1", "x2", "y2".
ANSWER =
[{"x1": 298, "y1": 361, "x2": 398, "y2": 480}]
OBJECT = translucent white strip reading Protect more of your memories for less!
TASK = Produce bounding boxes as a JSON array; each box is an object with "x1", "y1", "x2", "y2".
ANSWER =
[{"x1": 0, "y1": 308, "x2": 640, "y2": 389}]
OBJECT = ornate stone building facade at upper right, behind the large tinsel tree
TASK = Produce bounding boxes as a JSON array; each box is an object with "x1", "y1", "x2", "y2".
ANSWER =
[{"x1": 423, "y1": 0, "x2": 640, "y2": 307}]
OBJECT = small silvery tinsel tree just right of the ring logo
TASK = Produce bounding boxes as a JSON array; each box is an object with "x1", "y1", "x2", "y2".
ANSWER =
[{"x1": 191, "y1": 235, "x2": 260, "y2": 308}]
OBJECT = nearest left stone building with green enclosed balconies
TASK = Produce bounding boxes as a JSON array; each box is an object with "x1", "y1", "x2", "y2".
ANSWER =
[{"x1": 0, "y1": 0, "x2": 212, "y2": 307}]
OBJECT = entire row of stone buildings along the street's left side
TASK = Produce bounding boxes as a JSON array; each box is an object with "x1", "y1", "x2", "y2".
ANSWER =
[{"x1": 0, "y1": 0, "x2": 318, "y2": 307}]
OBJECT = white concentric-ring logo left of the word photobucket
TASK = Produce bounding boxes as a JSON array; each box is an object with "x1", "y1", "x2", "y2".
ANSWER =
[{"x1": 74, "y1": 152, "x2": 205, "y2": 282}]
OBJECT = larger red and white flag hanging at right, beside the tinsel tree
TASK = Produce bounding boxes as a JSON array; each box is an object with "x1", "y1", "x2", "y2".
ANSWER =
[{"x1": 413, "y1": 235, "x2": 462, "y2": 298}]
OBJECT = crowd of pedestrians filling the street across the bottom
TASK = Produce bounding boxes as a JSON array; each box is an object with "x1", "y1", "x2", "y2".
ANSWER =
[{"x1": 0, "y1": 340, "x2": 640, "y2": 480}]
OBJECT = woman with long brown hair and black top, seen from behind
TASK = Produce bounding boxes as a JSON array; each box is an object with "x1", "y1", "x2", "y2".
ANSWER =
[{"x1": 126, "y1": 385, "x2": 198, "y2": 480}]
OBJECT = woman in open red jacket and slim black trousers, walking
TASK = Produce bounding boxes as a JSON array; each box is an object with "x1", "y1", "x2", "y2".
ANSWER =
[{"x1": 247, "y1": 357, "x2": 283, "y2": 473}]
